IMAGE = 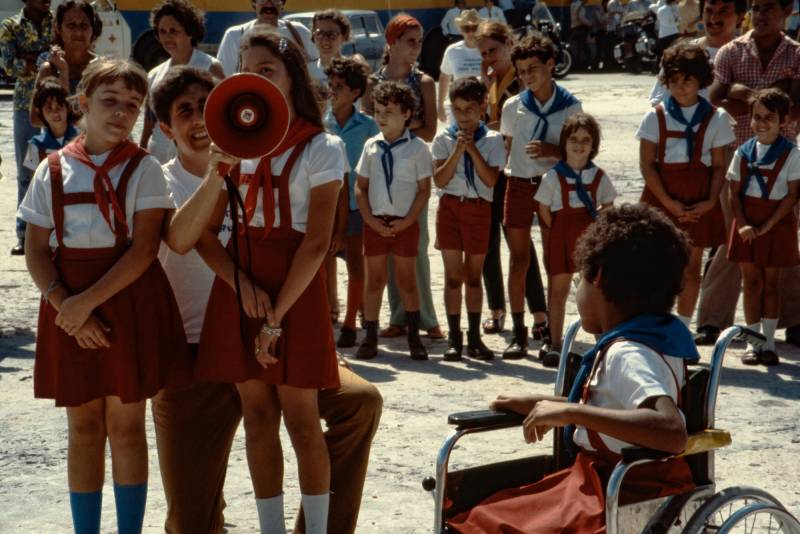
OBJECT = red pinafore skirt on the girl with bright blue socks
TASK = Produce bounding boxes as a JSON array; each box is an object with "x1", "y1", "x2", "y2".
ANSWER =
[{"x1": 33, "y1": 151, "x2": 191, "y2": 406}]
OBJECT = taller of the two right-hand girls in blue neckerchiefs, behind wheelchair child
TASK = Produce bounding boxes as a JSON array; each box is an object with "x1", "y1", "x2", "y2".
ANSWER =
[{"x1": 636, "y1": 43, "x2": 736, "y2": 325}]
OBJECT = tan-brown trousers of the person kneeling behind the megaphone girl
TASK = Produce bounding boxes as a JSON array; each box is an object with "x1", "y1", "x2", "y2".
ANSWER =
[{"x1": 152, "y1": 366, "x2": 383, "y2": 534}]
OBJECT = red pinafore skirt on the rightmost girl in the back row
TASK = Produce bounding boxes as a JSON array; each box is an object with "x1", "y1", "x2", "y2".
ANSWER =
[{"x1": 728, "y1": 150, "x2": 800, "y2": 269}]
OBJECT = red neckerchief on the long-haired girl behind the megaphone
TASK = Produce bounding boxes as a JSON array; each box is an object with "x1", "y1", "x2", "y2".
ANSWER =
[{"x1": 244, "y1": 118, "x2": 323, "y2": 237}]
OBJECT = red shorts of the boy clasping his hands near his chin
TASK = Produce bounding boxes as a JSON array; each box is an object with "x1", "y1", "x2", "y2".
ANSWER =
[{"x1": 436, "y1": 195, "x2": 492, "y2": 254}]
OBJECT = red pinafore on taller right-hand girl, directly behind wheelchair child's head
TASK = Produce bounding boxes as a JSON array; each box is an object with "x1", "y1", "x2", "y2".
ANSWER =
[{"x1": 640, "y1": 105, "x2": 725, "y2": 248}]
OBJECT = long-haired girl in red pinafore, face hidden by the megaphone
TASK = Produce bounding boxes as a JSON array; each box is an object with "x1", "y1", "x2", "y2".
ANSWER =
[{"x1": 170, "y1": 30, "x2": 345, "y2": 533}]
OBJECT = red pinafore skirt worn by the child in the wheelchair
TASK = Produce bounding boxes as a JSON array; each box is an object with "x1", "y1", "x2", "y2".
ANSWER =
[{"x1": 448, "y1": 342, "x2": 695, "y2": 534}]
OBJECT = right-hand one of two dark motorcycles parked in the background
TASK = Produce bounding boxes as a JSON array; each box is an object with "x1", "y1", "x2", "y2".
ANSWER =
[{"x1": 614, "y1": 11, "x2": 658, "y2": 74}]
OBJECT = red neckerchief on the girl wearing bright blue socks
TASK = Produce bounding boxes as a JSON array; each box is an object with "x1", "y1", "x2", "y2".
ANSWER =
[{"x1": 62, "y1": 135, "x2": 141, "y2": 235}]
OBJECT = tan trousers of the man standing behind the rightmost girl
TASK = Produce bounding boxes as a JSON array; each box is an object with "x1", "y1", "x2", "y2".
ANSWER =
[{"x1": 697, "y1": 183, "x2": 800, "y2": 330}]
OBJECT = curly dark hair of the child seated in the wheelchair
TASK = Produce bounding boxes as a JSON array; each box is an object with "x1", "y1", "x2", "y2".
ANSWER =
[{"x1": 575, "y1": 204, "x2": 689, "y2": 315}]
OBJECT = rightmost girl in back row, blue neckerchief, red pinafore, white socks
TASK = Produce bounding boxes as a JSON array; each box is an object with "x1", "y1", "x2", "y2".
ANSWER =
[{"x1": 728, "y1": 89, "x2": 800, "y2": 365}]
